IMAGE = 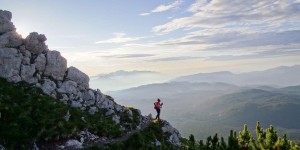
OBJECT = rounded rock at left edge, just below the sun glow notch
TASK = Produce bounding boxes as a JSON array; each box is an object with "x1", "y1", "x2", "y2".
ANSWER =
[{"x1": 0, "y1": 31, "x2": 23, "y2": 48}]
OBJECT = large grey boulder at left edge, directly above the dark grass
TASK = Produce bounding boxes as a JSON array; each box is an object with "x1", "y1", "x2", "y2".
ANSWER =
[{"x1": 0, "y1": 48, "x2": 23, "y2": 82}]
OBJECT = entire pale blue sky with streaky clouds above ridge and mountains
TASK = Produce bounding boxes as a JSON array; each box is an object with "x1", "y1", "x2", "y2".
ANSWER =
[{"x1": 0, "y1": 0, "x2": 300, "y2": 76}]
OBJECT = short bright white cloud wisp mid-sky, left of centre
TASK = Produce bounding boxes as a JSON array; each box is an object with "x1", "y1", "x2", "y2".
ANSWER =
[{"x1": 95, "y1": 33, "x2": 143, "y2": 44}]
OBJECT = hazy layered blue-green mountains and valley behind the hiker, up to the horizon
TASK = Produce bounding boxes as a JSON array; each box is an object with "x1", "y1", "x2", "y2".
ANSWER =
[{"x1": 108, "y1": 65, "x2": 300, "y2": 139}]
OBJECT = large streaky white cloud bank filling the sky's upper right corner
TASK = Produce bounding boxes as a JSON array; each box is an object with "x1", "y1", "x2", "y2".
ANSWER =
[{"x1": 152, "y1": 0, "x2": 300, "y2": 33}]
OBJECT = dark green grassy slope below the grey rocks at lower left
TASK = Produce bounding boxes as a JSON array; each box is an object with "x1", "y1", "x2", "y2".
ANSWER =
[{"x1": 0, "y1": 78, "x2": 122, "y2": 149}]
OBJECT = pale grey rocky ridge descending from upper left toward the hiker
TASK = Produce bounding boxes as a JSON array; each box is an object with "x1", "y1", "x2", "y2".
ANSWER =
[{"x1": 0, "y1": 10, "x2": 180, "y2": 149}]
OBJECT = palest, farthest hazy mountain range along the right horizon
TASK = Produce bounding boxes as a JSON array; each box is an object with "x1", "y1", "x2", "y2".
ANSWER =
[{"x1": 171, "y1": 65, "x2": 300, "y2": 87}]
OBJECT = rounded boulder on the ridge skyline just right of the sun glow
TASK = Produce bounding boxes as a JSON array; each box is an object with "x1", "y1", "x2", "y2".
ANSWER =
[{"x1": 25, "y1": 32, "x2": 48, "y2": 54}]
